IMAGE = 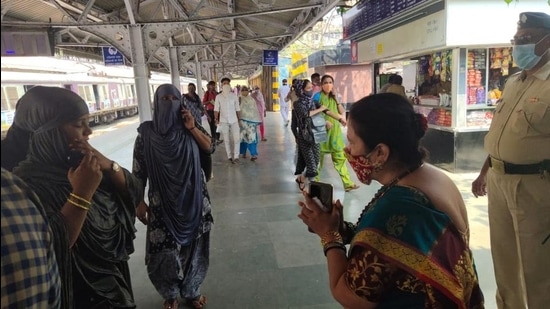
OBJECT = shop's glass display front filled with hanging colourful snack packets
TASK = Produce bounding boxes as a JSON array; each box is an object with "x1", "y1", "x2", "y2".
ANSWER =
[{"x1": 414, "y1": 47, "x2": 517, "y2": 171}]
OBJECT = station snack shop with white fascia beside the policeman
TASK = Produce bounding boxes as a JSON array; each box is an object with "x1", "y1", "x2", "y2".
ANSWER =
[{"x1": 350, "y1": 0, "x2": 545, "y2": 172}]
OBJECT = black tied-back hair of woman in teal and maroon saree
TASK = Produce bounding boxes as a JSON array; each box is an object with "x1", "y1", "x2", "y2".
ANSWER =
[{"x1": 349, "y1": 93, "x2": 427, "y2": 168}]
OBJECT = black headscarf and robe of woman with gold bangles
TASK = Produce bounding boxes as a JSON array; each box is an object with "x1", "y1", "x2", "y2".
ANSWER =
[{"x1": 14, "y1": 87, "x2": 143, "y2": 308}]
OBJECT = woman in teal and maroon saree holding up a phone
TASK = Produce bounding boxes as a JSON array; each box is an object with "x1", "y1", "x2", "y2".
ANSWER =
[{"x1": 298, "y1": 94, "x2": 484, "y2": 308}]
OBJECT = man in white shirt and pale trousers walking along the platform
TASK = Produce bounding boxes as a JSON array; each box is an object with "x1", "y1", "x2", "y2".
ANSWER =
[{"x1": 214, "y1": 77, "x2": 241, "y2": 164}]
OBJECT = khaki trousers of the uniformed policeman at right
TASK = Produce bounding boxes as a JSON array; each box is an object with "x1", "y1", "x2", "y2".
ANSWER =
[{"x1": 487, "y1": 169, "x2": 550, "y2": 309}]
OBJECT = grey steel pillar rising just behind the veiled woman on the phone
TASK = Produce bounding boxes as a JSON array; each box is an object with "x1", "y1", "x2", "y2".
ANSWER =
[{"x1": 128, "y1": 25, "x2": 153, "y2": 122}]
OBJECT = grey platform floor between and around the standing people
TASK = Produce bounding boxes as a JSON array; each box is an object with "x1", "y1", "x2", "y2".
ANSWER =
[{"x1": 90, "y1": 112, "x2": 496, "y2": 309}]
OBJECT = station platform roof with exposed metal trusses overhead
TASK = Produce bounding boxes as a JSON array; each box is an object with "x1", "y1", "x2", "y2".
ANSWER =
[{"x1": 2, "y1": 0, "x2": 351, "y2": 78}]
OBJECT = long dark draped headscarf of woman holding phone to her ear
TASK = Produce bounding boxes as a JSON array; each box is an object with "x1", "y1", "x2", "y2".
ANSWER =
[{"x1": 138, "y1": 84, "x2": 203, "y2": 245}]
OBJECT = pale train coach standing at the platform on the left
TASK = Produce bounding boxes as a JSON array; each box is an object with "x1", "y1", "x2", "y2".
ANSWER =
[{"x1": 1, "y1": 57, "x2": 205, "y2": 136}]
